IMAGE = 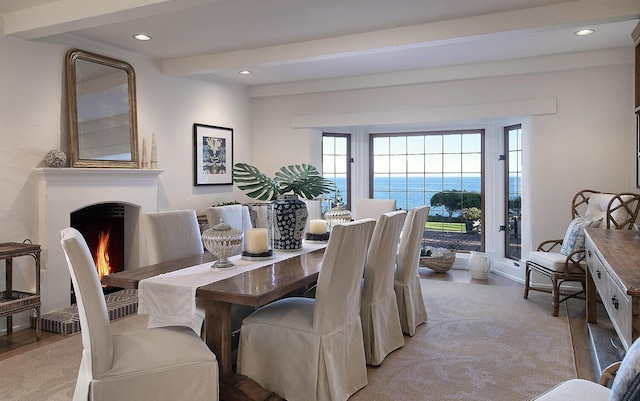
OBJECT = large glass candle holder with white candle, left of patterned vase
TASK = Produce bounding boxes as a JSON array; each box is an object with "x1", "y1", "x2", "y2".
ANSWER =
[{"x1": 241, "y1": 203, "x2": 275, "y2": 260}]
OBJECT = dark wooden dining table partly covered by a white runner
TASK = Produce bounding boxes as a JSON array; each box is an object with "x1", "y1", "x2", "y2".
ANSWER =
[{"x1": 102, "y1": 248, "x2": 324, "y2": 377}]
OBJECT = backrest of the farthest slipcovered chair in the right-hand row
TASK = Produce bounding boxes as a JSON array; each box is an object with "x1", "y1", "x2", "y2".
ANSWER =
[{"x1": 396, "y1": 205, "x2": 431, "y2": 284}]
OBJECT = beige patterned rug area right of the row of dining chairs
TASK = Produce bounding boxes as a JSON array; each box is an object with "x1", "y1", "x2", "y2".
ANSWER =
[{"x1": 349, "y1": 279, "x2": 576, "y2": 401}]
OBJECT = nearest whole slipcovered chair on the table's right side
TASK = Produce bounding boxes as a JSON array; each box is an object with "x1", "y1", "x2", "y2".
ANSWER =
[{"x1": 238, "y1": 219, "x2": 376, "y2": 401}]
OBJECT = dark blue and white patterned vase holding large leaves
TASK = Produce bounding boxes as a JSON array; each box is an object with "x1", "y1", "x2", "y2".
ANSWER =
[{"x1": 273, "y1": 195, "x2": 308, "y2": 251}]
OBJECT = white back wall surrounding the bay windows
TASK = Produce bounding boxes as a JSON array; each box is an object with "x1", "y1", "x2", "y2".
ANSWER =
[{"x1": 253, "y1": 48, "x2": 636, "y2": 280}]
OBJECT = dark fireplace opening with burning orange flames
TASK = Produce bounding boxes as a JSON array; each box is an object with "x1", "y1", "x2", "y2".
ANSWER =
[{"x1": 70, "y1": 203, "x2": 125, "y2": 304}]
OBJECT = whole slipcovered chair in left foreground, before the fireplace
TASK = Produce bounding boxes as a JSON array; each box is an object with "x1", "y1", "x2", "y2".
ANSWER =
[{"x1": 61, "y1": 228, "x2": 218, "y2": 401}]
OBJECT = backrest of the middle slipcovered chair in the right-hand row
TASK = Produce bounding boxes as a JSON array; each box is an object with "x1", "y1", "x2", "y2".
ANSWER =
[{"x1": 362, "y1": 210, "x2": 407, "y2": 305}]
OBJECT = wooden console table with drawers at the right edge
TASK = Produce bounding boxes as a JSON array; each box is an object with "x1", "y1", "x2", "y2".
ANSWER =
[{"x1": 585, "y1": 228, "x2": 640, "y2": 350}]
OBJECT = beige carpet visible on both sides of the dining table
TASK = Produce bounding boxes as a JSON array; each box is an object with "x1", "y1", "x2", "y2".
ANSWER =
[{"x1": 0, "y1": 280, "x2": 576, "y2": 401}]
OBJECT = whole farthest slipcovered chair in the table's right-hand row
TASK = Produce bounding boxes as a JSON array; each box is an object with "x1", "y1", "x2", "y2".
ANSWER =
[{"x1": 394, "y1": 205, "x2": 430, "y2": 336}]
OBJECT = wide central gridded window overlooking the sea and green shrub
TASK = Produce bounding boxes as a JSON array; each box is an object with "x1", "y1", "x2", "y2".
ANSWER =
[{"x1": 369, "y1": 129, "x2": 484, "y2": 250}]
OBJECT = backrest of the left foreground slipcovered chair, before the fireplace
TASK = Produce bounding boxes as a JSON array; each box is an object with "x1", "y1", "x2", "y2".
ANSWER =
[{"x1": 60, "y1": 228, "x2": 113, "y2": 380}]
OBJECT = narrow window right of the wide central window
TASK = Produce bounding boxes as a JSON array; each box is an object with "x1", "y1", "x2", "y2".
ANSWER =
[{"x1": 504, "y1": 124, "x2": 522, "y2": 260}]
